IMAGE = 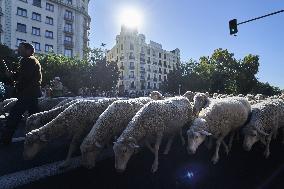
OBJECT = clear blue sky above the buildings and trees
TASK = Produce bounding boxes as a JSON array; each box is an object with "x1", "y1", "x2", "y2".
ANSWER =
[{"x1": 89, "y1": 0, "x2": 284, "y2": 89}]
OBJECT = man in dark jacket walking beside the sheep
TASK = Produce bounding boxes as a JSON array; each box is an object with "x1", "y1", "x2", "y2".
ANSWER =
[{"x1": 0, "y1": 43, "x2": 42, "y2": 145}]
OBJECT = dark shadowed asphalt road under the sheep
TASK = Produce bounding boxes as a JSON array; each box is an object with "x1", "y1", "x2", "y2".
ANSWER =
[{"x1": 0, "y1": 119, "x2": 284, "y2": 189}]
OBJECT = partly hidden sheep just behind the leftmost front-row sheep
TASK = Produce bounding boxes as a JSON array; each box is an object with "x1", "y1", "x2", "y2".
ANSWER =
[{"x1": 25, "y1": 99, "x2": 83, "y2": 133}]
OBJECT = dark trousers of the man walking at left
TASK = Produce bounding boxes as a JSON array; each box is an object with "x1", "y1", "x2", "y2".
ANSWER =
[{"x1": 2, "y1": 98, "x2": 39, "y2": 143}]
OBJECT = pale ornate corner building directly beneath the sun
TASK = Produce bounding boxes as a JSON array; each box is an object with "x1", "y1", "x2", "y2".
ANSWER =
[{"x1": 107, "y1": 26, "x2": 180, "y2": 92}]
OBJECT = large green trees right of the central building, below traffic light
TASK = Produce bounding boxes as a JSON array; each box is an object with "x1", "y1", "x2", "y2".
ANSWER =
[{"x1": 163, "y1": 48, "x2": 280, "y2": 95}]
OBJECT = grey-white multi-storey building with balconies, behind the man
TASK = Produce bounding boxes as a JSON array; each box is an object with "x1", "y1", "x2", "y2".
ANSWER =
[{"x1": 0, "y1": 0, "x2": 91, "y2": 58}]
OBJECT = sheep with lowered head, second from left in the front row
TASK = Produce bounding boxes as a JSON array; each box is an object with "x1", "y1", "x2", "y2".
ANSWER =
[{"x1": 80, "y1": 97, "x2": 155, "y2": 168}]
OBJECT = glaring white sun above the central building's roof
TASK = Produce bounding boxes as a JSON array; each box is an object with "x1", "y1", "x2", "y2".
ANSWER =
[{"x1": 119, "y1": 8, "x2": 142, "y2": 28}]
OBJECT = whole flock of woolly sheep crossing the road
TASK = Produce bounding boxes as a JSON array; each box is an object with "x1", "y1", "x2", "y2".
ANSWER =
[{"x1": 0, "y1": 91, "x2": 284, "y2": 172}]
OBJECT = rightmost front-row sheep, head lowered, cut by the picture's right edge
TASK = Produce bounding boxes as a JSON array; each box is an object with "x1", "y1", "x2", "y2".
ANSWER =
[{"x1": 243, "y1": 99, "x2": 284, "y2": 158}]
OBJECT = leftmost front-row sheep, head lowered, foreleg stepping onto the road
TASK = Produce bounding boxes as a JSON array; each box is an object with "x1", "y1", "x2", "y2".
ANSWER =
[{"x1": 23, "y1": 98, "x2": 117, "y2": 168}]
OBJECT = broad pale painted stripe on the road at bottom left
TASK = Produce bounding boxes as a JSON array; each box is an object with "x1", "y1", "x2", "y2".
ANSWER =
[{"x1": 0, "y1": 157, "x2": 81, "y2": 189}]
